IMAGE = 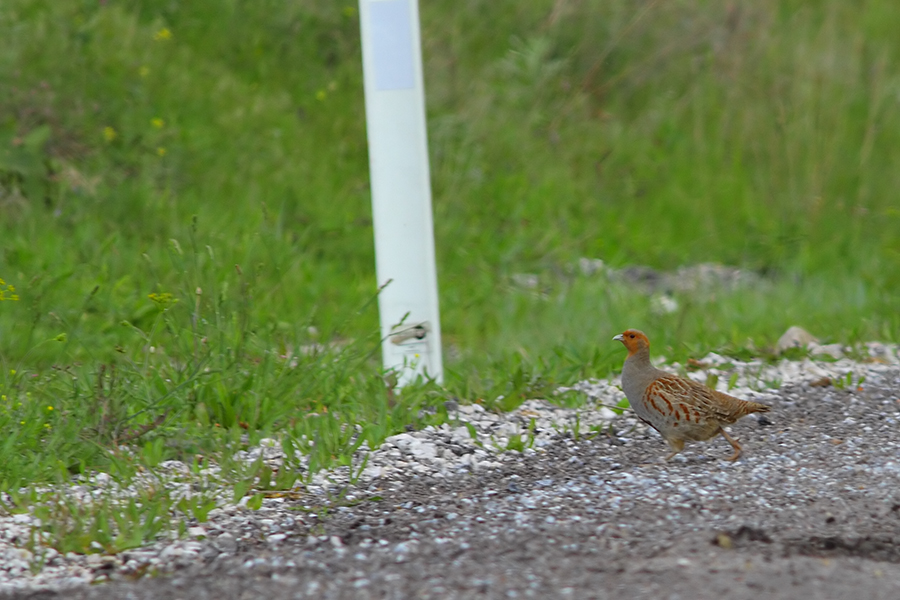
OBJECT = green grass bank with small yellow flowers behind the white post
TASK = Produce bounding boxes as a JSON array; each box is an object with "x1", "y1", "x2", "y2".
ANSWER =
[{"x1": 0, "y1": 0, "x2": 900, "y2": 547}]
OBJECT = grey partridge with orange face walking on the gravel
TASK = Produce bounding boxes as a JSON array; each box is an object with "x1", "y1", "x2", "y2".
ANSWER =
[{"x1": 613, "y1": 329, "x2": 769, "y2": 461}]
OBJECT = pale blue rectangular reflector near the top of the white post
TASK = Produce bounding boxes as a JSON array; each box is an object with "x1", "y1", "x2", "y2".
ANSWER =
[{"x1": 369, "y1": 0, "x2": 415, "y2": 91}]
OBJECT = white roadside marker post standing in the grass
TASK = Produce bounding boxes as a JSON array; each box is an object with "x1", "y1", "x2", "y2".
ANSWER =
[{"x1": 359, "y1": 0, "x2": 443, "y2": 385}]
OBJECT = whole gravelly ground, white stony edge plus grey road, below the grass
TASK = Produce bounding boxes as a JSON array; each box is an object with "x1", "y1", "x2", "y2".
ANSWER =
[{"x1": 0, "y1": 344, "x2": 900, "y2": 600}]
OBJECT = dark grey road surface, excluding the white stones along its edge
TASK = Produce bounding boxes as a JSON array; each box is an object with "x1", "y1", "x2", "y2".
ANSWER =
[{"x1": 7, "y1": 373, "x2": 900, "y2": 600}]
